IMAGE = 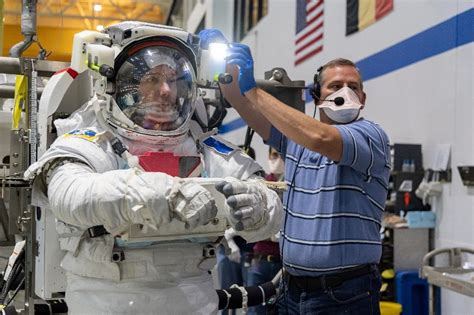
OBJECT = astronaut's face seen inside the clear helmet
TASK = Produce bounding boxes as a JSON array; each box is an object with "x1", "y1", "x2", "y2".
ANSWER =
[{"x1": 138, "y1": 64, "x2": 179, "y2": 130}]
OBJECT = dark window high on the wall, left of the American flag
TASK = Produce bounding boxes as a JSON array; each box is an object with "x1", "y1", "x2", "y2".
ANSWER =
[{"x1": 234, "y1": 0, "x2": 268, "y2": 41}]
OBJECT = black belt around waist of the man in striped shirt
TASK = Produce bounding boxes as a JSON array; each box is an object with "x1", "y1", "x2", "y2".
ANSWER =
[{"x1": 283, "y1": 264, "x2": 374, "y2": 292}]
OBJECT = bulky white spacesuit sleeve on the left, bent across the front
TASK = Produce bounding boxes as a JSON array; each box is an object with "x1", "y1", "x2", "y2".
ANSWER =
[{"x1": 47, "y1": 163, "x2": 174, "y2": 234}]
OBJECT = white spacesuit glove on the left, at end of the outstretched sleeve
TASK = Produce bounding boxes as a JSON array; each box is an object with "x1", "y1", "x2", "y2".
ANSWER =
[{"x1": 168, "y1": 181, "x2": 217, "y2": 230}]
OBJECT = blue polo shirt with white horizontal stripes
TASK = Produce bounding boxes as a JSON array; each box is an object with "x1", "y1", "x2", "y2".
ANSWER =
[{"x1": 267, "y1": 119, "x2": 391, "y2": 276}]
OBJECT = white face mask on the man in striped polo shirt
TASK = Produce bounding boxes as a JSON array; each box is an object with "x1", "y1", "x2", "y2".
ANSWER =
[{"x1": 318, "y1": 86, "x2": 363, "y2": 124}]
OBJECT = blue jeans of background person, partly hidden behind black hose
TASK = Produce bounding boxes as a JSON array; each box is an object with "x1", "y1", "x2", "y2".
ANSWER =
[{"x1": 247, "y1": 259, "x2": 281, "y2": 315}]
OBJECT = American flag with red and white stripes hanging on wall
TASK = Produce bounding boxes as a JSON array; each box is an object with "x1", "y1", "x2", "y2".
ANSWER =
[{"x1": 295, "y1": 0, "x2": 324, "y2": 66}]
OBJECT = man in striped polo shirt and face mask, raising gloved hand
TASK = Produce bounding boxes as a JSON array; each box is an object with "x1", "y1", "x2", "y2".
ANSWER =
[{"x1": 222, "y1": 44, "x2": 391, "y2": 315}]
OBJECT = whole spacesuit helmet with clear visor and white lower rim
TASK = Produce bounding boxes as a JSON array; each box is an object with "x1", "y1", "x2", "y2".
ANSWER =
[{"x1": 109, "y1": 36, "x2": 197, "y2": 143}]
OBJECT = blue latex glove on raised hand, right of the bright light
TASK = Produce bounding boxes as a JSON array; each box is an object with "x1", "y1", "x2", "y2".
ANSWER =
[{"x1": 226, "y1": 43, "x2": 257, "y2": 94}]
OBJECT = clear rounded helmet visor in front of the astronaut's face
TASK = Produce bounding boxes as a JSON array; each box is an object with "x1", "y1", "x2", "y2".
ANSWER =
[{"x1": 115, "y1": 46, "x2": 196, "y2": 131}]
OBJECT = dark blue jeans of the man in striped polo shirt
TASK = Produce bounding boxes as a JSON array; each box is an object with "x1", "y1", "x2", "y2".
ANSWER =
[{"x1": 277, "y1": 265, "x2": 382, "y2": 315}]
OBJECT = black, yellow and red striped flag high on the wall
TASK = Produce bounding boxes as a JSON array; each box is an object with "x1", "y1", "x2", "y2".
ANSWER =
[{"x1": 346, "y1": 0, "x2": 393, "y2": 36}]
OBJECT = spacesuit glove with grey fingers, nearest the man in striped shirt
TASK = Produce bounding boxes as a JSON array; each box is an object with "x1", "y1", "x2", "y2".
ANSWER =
[{"x1": 216, "y1": 177, "x2": 268, "y2": 231}]
